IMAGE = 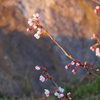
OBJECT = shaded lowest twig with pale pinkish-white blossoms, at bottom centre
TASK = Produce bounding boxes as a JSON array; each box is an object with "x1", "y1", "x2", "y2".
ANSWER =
[{"x1": 35, "y1": 65, "x2": 72, "y2": 100}]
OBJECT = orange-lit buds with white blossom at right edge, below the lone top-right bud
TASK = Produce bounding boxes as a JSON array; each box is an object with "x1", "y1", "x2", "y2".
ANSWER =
[{"x1": 90, "y1": 34, "x2": 100, "y2": 57}]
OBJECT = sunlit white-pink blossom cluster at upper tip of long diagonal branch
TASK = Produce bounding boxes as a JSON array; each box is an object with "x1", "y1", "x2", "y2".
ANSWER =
[{"x1": 27, "y1": 13, "x2": 44, "y2": 39}]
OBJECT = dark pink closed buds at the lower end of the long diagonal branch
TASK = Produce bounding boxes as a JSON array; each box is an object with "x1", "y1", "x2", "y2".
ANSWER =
[{"x1": 65, "y1": 60, "x2": 99, "y2": 74}]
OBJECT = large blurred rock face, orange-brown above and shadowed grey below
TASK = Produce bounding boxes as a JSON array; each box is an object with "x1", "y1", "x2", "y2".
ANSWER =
[{"x1": 0, "y1": 0, "x2": 99, "y2": 97}]
